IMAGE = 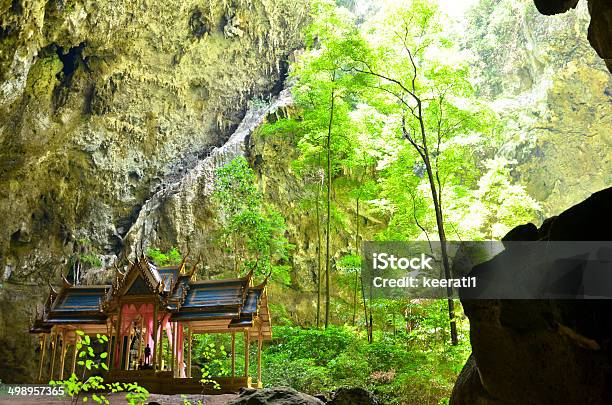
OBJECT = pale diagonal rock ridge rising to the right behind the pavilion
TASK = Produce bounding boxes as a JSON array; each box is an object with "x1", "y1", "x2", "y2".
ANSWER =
[{"x1": 119, "y1": 89, "x2": 293, "y2": 274}]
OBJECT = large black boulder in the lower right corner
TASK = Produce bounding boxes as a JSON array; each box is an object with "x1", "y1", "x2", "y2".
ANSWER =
[{"x1": 451, "y1": 188, "x2": 612, "y2": 405}]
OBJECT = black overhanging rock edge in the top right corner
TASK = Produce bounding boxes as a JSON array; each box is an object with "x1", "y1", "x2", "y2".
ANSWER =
[{"x1": 534, "y1": 0, "x2": 612, "y2": 71}]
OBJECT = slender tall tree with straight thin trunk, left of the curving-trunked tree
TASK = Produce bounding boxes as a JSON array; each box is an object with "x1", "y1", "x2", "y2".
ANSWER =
[{"x1": 293, "y1": 1, "x2": 364, "y2": 327}]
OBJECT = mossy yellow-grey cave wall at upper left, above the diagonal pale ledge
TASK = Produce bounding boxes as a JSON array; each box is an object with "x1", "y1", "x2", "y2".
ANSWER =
[{"x1": 0, "y1": 0, "x2": 307, "y2": 283}]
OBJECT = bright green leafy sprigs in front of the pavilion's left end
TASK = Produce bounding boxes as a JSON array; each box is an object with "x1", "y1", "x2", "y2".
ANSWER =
[{"x1": 49, "y1": 330, "x2": 149, "y2": 405}]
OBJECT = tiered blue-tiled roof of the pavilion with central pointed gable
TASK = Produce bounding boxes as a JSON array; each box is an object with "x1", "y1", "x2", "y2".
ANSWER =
[{"x1": 30, "y1": 256, "x2": 271, "y2": 336}]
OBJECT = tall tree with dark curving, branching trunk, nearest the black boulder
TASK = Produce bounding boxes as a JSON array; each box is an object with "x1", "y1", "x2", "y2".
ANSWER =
[{"x1": 343, "y1": 0, "x2": 498, "y2": 345}]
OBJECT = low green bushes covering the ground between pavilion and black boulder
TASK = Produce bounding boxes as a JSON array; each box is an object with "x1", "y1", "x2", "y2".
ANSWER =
[{"x1": 263, "y1": 300, "x2": 470, "y2": 404}]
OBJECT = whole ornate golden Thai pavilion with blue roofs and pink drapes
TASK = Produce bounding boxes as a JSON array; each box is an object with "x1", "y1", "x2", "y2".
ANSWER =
[{"x1": 30, "y1": 255, "x2": 272, "y2": 394}]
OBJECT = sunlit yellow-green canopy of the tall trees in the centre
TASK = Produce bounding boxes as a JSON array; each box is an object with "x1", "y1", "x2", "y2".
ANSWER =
[{"x1": 268, "y1": 0, "x2": 538, "y2": 246}]
